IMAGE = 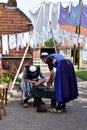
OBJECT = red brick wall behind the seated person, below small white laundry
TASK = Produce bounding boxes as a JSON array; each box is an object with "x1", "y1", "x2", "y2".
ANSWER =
[{"x1": 2, "y1": 48, "x2": 33, "y2": 73}]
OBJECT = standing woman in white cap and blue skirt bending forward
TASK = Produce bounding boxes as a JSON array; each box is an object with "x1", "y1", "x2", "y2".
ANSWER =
[{"x1": 41, "y1": 52, "x2": 78, "y2": 112}]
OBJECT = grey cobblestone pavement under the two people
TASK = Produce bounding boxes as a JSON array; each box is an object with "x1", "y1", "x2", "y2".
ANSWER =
[{"x1": 0, "y1": 80, "x2": 87, "y2": 130}]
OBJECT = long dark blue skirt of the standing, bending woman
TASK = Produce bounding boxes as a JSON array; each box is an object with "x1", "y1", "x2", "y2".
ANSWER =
[{"x1": 54, "y1": 59, "x2": 78, "y2": 103}]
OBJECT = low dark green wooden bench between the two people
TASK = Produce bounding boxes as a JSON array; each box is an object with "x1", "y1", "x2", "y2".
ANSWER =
[{"x1": 32, "y1": 85, "x2": 56, "y2": 108}]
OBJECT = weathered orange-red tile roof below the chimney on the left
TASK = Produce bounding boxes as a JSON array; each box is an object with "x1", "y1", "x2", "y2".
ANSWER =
[{"x1": 0, "y1": 3, "x2": 32, "y2": 34}]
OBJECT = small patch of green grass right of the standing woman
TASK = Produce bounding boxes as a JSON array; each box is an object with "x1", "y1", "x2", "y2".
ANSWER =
[{"x1": 75, "y1": 70, "x2": 87, "y2": 81}]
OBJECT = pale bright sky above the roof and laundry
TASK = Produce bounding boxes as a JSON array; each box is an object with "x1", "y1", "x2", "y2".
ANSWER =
[{"x1": 0, "y1": 0, "x2": 81, "y2": 14}]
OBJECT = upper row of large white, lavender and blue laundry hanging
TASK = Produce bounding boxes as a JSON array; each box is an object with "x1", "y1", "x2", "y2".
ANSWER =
[{"x1": 29, "y1": 2, "x2": 87, "y2": 33}]
